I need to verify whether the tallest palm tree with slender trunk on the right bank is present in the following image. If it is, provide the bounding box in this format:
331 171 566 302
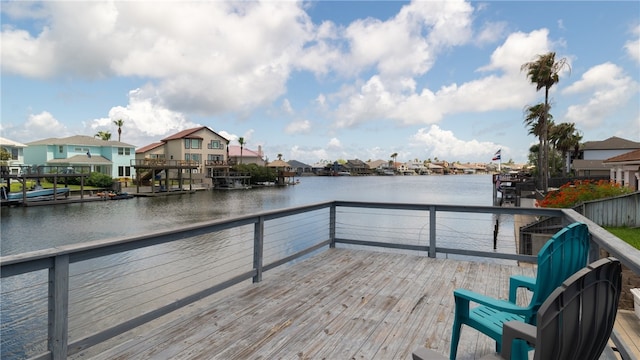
520 52 569 192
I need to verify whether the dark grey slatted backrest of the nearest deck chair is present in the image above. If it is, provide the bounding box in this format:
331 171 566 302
534 258 622 360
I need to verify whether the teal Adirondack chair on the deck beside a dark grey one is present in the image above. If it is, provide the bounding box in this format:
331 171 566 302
449 222 589 360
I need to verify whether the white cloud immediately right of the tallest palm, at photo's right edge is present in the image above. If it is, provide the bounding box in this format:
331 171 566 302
562 63 639 129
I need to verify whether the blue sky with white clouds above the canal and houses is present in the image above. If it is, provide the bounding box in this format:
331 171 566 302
0 0 640 164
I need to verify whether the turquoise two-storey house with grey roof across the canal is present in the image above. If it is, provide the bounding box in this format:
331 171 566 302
23 135 135 179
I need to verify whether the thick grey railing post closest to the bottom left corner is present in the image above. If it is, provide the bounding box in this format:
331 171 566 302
47 255 69 360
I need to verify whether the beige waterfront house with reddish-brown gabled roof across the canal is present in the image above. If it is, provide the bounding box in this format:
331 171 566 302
136 126 231 182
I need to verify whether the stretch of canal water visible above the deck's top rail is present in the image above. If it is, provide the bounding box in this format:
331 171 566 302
0 175 493 256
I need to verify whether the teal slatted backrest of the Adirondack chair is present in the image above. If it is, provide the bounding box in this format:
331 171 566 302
527 222 590 323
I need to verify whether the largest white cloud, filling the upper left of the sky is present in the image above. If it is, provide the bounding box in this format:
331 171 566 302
2 1 311 114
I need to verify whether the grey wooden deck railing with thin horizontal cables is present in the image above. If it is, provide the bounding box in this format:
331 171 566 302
0 201 640 359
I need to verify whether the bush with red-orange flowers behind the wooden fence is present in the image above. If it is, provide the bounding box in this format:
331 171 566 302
537 180 631 208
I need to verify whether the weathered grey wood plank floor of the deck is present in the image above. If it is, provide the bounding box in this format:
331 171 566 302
78 249 534 360
